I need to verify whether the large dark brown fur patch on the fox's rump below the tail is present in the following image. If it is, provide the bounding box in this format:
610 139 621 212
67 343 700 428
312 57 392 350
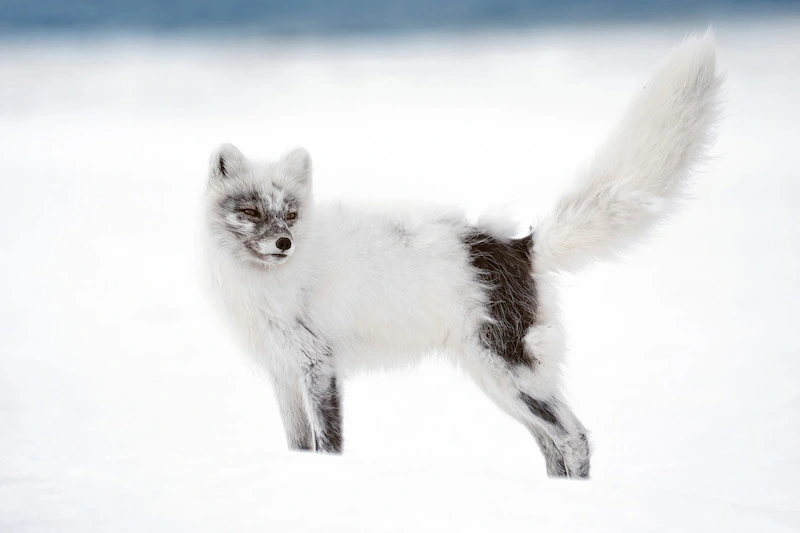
463 230 536 366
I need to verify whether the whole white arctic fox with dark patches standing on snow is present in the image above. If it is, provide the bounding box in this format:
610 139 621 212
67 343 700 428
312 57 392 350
200 34 720 478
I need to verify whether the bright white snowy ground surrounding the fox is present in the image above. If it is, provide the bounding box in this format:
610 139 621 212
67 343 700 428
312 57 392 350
0 20 800 533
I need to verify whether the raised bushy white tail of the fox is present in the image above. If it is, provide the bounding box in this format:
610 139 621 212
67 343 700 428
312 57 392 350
534 31 720 273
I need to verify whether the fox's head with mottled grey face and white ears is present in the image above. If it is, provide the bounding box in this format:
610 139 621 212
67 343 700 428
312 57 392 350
207 144 311 266
